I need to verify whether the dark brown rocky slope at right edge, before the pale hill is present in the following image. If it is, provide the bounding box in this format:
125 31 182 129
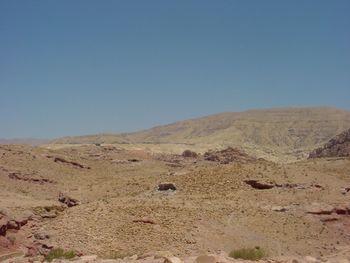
309 129 350 158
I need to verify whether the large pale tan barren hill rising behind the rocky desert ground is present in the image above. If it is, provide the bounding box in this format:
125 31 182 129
52 107 350 160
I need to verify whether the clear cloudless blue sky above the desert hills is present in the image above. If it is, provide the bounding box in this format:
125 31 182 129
0 0 350 138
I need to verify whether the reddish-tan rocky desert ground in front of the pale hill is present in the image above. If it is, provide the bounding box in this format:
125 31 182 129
0 144 350 262
